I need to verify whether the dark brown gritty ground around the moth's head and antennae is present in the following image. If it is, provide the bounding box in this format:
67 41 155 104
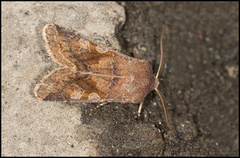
78 2 239 156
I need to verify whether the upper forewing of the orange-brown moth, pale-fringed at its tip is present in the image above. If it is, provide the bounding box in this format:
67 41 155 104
43 24 114 71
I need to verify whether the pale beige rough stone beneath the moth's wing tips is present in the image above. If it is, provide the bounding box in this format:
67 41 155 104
1 2 125 156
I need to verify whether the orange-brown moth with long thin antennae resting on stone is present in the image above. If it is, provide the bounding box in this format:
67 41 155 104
34 24 174 135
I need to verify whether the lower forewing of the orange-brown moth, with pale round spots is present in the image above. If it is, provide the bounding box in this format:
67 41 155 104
34 68 115 102
